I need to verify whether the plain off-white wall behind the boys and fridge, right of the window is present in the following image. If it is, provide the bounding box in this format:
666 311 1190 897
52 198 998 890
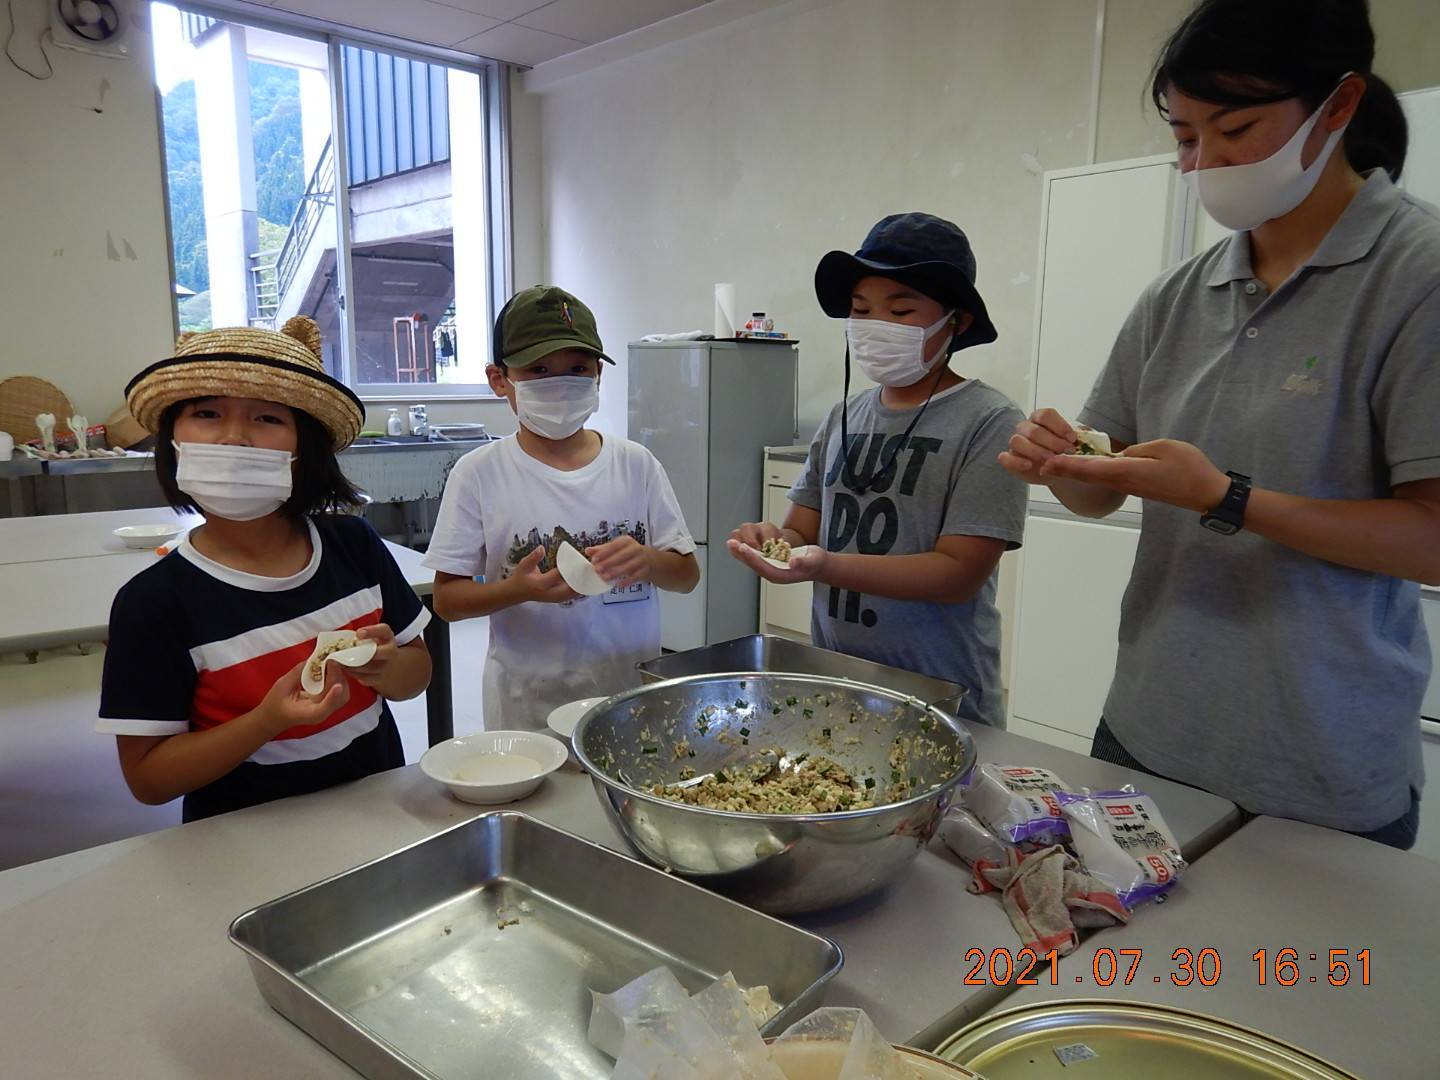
541 0 1094 432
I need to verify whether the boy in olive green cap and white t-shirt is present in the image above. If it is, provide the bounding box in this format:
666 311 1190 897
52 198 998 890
425 285 700 729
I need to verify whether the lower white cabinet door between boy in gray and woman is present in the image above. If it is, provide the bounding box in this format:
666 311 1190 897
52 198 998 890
1009 516 1140 743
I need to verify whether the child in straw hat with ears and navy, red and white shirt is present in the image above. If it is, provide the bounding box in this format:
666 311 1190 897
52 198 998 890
96 317 431 821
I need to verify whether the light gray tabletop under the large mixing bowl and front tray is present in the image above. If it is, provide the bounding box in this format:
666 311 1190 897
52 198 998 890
0 714 1234 1079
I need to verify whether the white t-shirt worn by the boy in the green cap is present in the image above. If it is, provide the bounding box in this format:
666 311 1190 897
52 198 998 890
425 435 696 730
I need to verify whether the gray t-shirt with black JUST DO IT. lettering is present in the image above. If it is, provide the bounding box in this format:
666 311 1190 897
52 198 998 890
789 379 1025 727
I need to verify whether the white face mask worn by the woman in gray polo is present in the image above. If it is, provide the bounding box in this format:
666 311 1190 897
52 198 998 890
1185 75 1349 232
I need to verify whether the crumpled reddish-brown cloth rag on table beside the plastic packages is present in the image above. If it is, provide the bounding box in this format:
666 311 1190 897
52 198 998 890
975 844 1130 956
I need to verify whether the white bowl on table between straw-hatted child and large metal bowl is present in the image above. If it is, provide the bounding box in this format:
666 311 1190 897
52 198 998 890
420 732 566 805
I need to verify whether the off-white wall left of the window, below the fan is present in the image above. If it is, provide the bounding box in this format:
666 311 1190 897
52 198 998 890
0 0 174 423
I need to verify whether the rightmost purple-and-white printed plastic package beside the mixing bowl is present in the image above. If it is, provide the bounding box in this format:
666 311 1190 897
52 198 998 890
1060 791 1187 907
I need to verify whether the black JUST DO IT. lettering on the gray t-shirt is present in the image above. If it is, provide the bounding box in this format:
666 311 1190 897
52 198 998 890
825 432 945 628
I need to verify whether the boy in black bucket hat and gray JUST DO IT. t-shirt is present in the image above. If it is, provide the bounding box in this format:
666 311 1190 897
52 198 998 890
729 213 1025 727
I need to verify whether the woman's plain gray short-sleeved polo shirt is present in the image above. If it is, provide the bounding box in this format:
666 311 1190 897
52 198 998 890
1080 171 1440 831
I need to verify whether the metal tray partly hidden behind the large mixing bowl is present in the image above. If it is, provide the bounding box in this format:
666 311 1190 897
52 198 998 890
635 634 969 716
